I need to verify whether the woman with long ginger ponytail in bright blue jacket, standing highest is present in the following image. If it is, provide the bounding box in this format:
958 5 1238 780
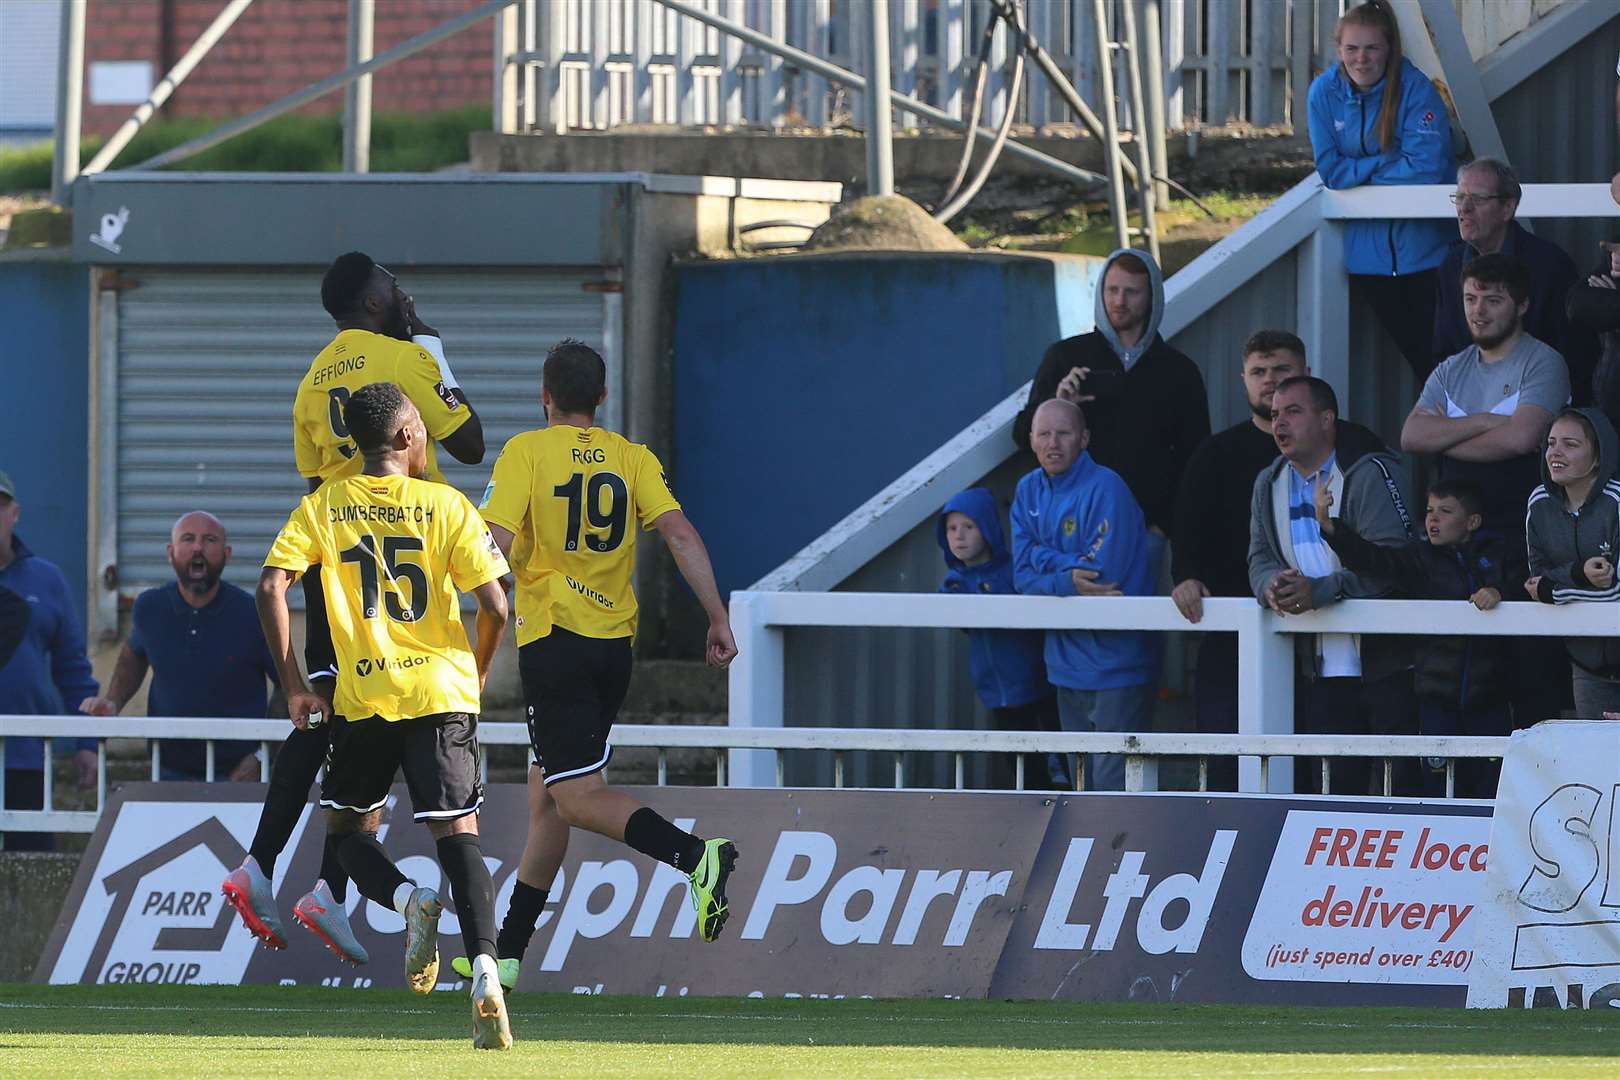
1307 0 1456 382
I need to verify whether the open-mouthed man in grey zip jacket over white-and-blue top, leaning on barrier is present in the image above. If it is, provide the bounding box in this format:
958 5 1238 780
1249 376 1418 795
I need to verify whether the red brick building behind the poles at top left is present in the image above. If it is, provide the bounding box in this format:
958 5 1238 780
84 0 494 134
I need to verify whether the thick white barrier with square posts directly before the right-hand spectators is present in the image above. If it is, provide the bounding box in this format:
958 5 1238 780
731 593 1620 792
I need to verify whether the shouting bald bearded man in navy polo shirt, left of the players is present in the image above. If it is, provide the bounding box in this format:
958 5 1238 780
79 510 275 780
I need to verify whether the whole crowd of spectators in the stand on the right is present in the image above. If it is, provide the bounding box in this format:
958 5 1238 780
940 0 1620 797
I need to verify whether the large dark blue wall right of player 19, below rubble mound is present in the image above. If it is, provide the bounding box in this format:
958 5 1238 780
674 253 1102 594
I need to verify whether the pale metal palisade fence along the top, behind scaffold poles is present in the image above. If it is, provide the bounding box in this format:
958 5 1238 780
496 0 1338 133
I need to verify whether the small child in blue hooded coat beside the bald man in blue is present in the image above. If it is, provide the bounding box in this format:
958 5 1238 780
936 487 1074 790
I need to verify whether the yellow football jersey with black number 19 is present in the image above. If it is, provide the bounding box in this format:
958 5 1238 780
480 424 680 646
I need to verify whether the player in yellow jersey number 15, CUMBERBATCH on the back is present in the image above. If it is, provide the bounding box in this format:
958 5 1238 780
258 382 512 1049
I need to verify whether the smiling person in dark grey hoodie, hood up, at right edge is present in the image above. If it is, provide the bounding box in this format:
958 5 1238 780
1524 408 1620 721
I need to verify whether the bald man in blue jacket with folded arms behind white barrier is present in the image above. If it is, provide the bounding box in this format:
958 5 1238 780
1013 398 1160 790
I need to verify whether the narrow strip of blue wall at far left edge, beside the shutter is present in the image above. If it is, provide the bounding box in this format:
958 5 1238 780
0 259 89 617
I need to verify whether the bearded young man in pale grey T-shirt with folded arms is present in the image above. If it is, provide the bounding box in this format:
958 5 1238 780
1401 254 1570 727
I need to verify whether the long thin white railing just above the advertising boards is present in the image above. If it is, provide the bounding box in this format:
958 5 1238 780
0 714 1508 832
